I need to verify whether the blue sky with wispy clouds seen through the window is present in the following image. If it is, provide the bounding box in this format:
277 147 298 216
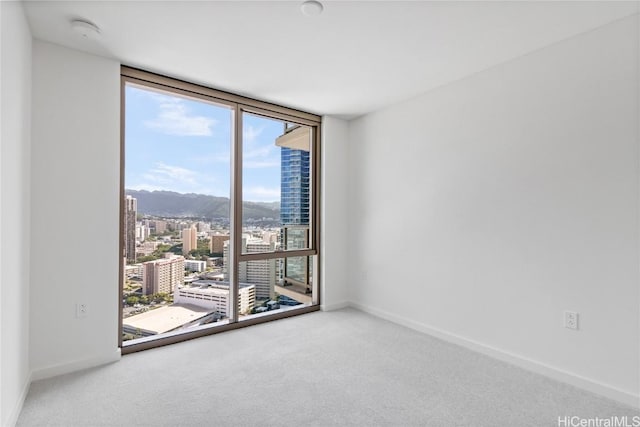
125 84 284 202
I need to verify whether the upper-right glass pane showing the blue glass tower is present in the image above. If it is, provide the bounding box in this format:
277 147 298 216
242 113 312 253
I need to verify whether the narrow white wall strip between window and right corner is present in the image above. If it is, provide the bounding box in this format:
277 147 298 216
320 116 349 310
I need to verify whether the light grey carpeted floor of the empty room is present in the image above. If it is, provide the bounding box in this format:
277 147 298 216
18 309 640 427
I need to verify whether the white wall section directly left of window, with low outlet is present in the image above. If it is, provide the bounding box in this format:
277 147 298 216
31 41 120 379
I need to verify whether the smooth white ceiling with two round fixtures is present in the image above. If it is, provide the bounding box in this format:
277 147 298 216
24 0 640 119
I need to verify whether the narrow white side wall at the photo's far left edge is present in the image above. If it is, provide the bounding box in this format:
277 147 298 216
0 2 31 426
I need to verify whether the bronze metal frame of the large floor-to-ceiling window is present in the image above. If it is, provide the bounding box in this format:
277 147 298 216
117 65 322 354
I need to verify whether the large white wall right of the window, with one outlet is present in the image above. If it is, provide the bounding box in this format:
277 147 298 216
349 17 640 405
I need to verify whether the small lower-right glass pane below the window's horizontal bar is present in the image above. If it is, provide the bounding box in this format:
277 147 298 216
239 256 313 321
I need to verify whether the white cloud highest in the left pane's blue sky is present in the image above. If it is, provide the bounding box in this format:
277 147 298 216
144 94 217 136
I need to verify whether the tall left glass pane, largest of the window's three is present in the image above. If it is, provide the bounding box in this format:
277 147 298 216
122 84 233 341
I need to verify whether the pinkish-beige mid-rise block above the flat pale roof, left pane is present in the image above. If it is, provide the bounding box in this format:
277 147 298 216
142 255 184 295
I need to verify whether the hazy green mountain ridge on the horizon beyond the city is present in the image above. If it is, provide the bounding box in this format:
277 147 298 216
125 190 280 220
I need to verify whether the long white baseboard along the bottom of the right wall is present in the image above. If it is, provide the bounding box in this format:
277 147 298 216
349 302 640 409
